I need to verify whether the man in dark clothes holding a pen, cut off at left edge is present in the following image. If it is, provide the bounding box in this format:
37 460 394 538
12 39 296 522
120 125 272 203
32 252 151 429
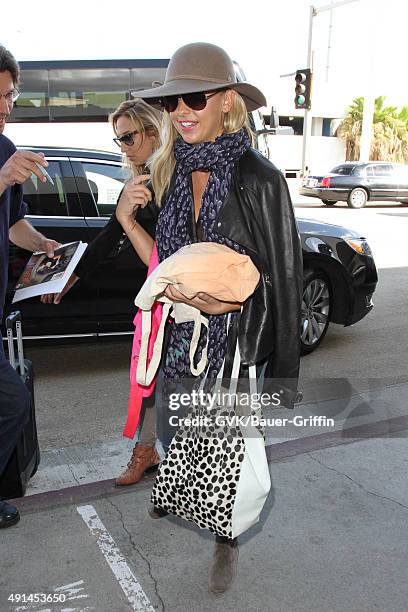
0 45 58 528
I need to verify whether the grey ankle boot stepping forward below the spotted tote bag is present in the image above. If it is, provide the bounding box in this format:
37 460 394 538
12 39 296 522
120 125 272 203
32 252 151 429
208 536 238 593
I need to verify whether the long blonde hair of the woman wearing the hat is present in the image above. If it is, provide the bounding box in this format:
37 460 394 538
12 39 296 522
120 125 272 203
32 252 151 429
150 91 255 206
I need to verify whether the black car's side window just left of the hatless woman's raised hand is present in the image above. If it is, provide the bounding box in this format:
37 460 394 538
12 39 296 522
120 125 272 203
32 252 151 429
82 162 131 217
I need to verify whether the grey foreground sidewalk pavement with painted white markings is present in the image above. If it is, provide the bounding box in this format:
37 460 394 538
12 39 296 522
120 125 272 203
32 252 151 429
0 432 408 612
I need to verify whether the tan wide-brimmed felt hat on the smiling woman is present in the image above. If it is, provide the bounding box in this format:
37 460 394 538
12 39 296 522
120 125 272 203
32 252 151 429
132 43 266 111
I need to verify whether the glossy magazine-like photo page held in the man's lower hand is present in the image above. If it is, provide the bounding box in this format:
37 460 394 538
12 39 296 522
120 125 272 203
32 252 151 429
13 241 88 302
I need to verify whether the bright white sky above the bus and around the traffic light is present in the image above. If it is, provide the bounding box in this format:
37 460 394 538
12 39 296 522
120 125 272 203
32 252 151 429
0 0 408 116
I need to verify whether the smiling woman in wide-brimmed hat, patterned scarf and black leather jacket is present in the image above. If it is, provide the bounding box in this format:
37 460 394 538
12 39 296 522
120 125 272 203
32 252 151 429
122 43 302 593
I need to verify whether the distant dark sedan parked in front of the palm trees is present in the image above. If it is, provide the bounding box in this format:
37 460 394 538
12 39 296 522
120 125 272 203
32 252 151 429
300 162 408 208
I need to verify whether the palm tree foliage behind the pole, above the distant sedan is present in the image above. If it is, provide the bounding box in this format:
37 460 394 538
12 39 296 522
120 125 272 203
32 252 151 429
338 96 408 162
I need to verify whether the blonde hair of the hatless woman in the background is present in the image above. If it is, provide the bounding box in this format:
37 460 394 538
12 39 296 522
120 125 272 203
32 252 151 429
109 98 161 176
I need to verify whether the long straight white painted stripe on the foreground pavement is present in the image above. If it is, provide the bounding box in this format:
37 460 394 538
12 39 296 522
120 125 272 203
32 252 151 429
77 505 154 612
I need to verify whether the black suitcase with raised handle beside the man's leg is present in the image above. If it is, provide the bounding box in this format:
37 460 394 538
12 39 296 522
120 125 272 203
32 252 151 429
0 311 40 499
